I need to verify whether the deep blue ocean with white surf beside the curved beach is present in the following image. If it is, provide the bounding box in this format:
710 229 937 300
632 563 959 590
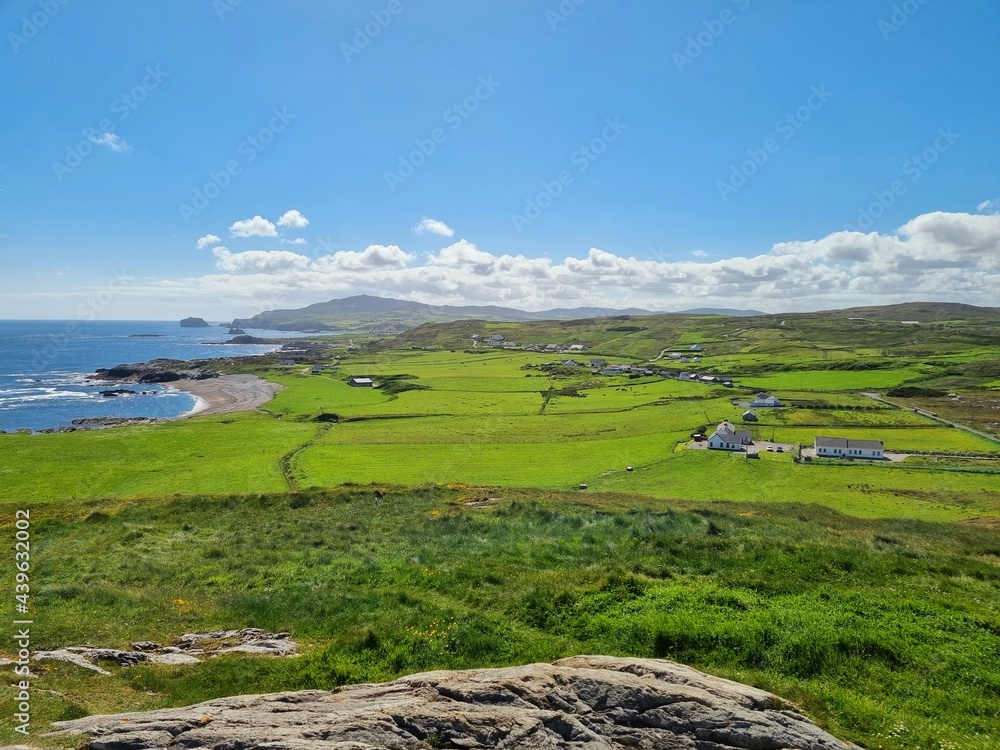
0 320 301 432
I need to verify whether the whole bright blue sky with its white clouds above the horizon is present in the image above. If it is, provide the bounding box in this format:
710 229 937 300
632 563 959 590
0 0 1000 319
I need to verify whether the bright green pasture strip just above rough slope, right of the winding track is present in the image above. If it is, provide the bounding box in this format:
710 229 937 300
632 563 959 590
293 432 1000 521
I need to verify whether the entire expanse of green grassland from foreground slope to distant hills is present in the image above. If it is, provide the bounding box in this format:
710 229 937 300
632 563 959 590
0 314 1000 750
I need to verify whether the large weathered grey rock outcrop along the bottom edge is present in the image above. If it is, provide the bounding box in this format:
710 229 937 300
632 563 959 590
56 656 854 750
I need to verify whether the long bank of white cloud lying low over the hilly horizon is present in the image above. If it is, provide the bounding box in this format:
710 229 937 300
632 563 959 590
56 212 1000 318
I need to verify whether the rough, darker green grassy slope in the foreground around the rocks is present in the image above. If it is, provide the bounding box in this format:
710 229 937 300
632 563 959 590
0 488 1000 750
